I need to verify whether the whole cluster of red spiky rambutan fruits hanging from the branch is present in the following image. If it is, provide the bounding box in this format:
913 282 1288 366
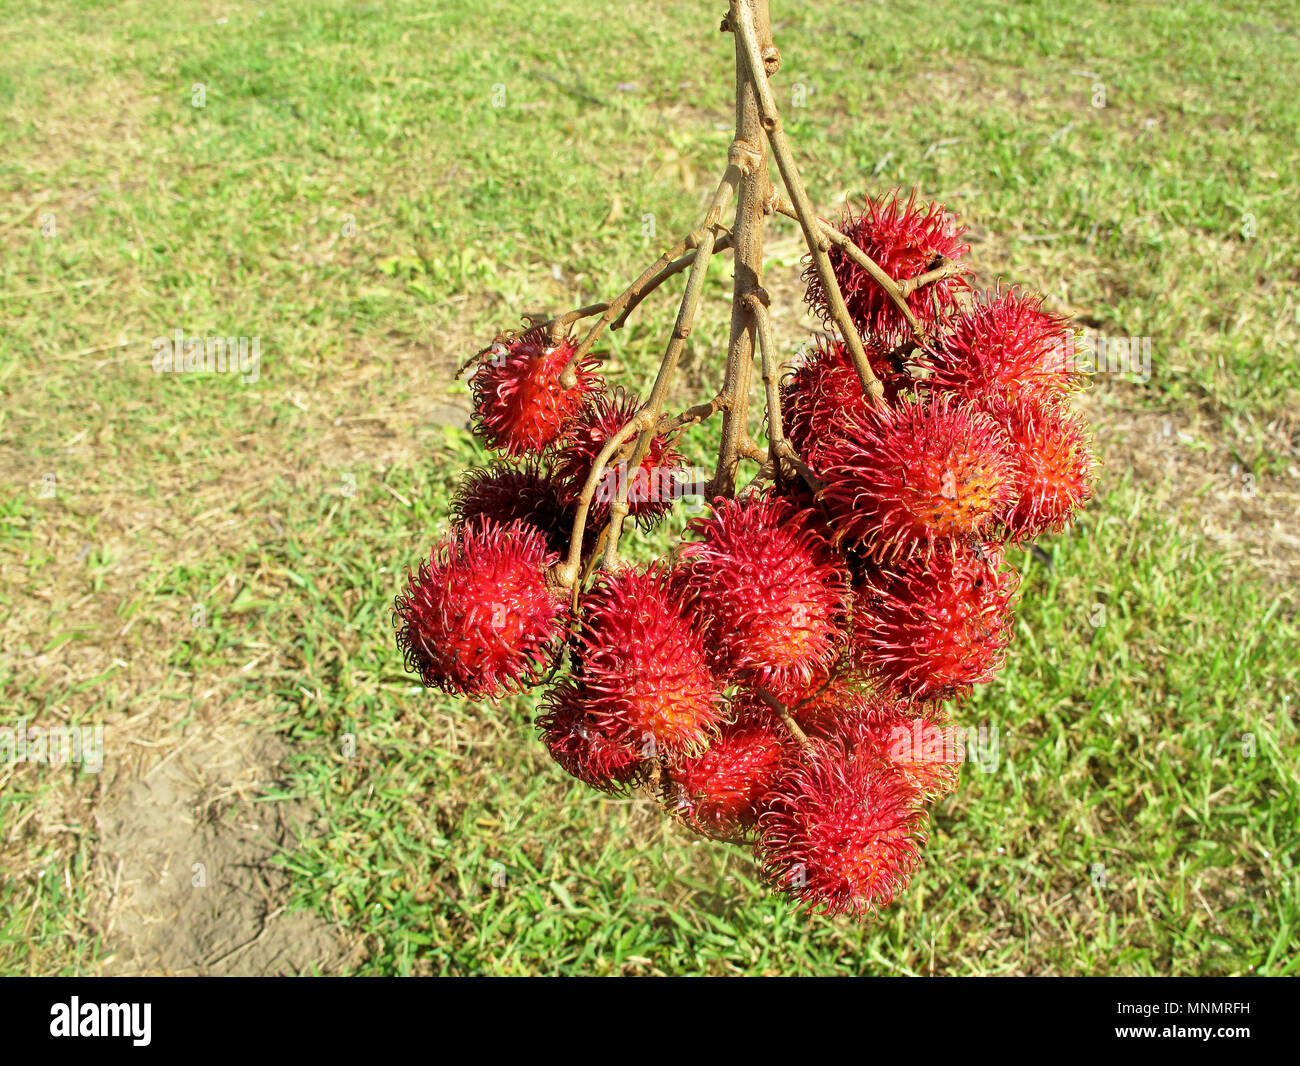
395 187 1096 915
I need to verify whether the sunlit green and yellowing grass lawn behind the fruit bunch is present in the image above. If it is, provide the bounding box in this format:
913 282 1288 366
0 0 1300 974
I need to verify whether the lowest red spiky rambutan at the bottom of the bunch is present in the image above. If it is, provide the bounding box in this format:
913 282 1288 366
758 738 926 917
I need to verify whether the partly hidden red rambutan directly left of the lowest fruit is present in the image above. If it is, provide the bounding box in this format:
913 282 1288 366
667 719 789 837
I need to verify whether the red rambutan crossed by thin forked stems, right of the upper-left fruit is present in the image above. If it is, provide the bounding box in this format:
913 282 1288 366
555 389 686 528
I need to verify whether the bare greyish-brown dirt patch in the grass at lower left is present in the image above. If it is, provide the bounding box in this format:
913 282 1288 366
94 728 350 976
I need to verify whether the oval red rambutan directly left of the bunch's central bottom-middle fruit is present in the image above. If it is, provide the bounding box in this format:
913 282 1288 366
576 567 722 757
